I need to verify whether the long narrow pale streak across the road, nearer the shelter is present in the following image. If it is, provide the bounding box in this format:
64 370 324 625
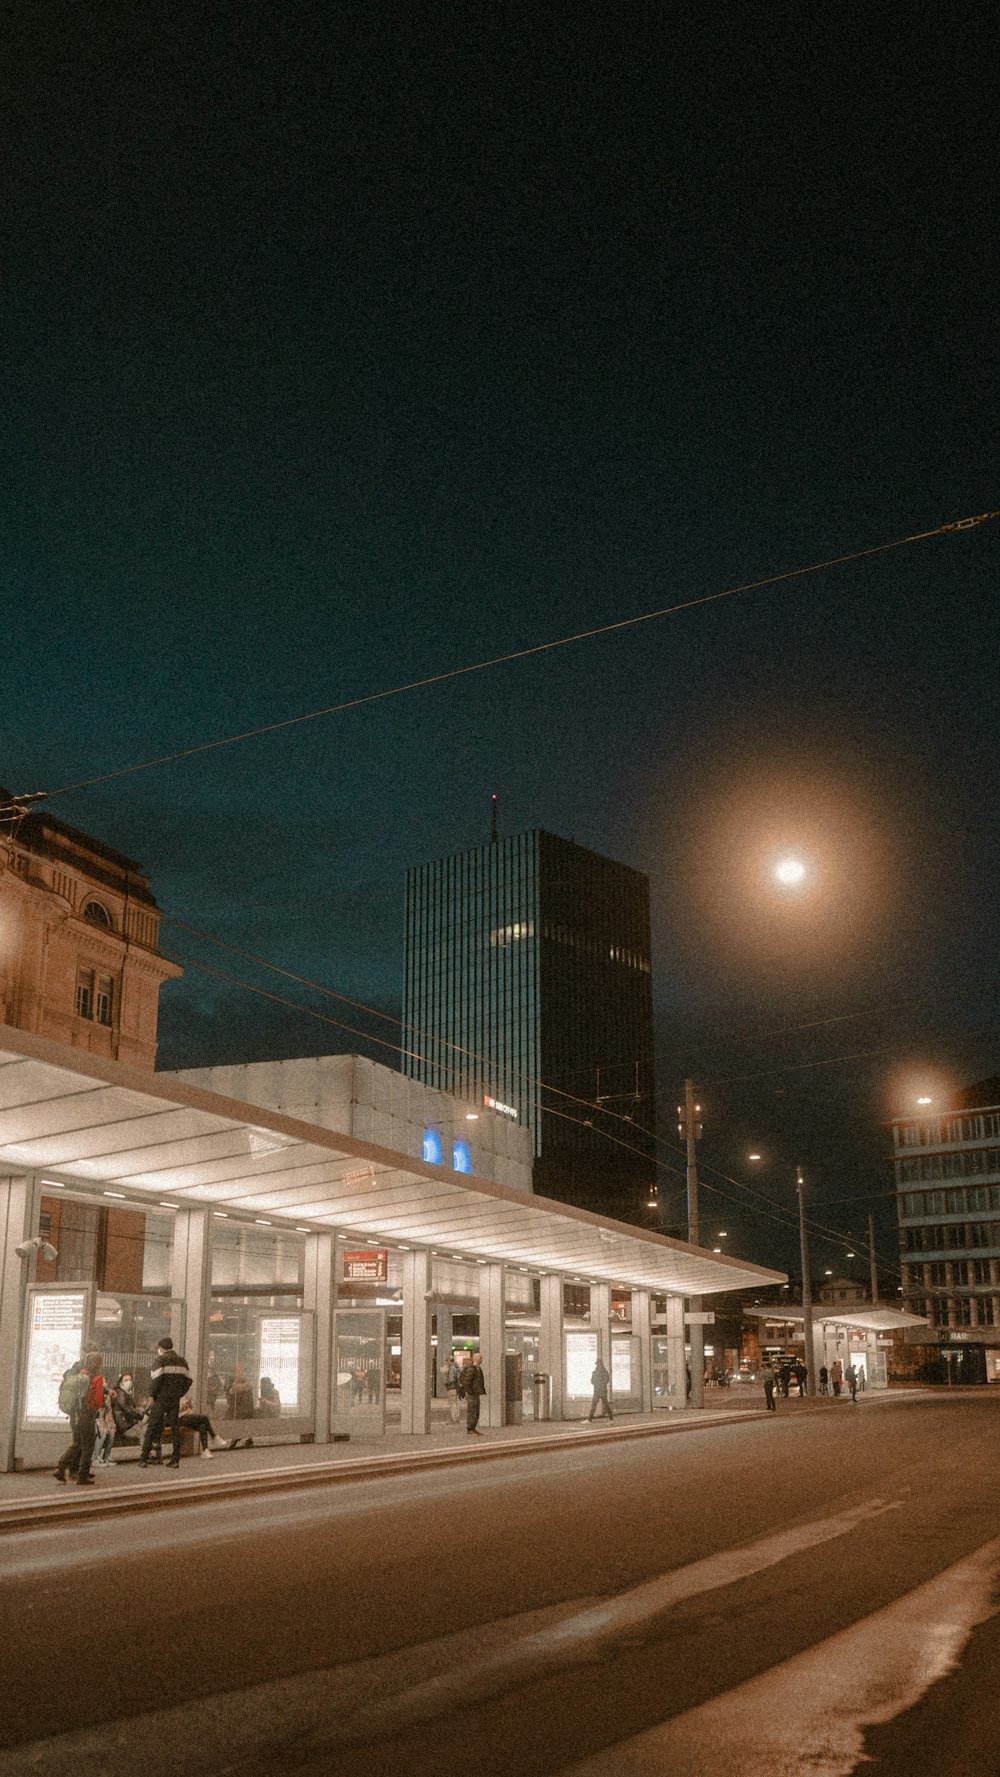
0 1498 906 1777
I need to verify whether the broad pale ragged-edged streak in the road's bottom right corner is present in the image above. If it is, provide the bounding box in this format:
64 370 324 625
560 1537 1000 1777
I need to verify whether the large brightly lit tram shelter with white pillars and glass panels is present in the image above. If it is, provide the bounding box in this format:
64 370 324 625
0 1027 783 1471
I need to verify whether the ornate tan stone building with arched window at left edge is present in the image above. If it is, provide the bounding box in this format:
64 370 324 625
0 789 181 1068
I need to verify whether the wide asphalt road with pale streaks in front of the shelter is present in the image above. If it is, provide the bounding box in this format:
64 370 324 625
0 1390 1000 1777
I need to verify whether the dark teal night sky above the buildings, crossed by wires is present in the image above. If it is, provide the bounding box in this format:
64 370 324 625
0 0 1000 1281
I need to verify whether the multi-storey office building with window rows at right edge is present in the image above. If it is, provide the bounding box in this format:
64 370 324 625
892 1079 1000 1383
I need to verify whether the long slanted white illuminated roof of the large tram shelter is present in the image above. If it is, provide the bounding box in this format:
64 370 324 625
0 1027 785 1295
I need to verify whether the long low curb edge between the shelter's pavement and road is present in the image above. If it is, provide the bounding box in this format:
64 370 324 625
0 1407 766 1535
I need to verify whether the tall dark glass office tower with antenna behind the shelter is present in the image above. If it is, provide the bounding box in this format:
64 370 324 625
403 832 655 1221
